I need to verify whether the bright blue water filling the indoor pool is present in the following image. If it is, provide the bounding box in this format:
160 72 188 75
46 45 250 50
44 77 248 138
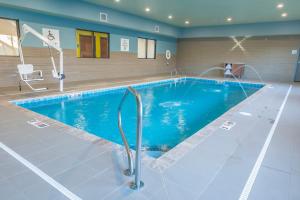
16 78 262 157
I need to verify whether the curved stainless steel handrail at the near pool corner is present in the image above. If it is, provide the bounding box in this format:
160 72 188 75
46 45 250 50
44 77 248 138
118 86 144 190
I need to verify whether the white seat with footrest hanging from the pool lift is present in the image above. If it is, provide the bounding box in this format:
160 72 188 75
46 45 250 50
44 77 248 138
18 64 47 91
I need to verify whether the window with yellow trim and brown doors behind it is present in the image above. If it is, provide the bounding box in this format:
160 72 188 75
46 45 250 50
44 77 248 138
76 30 109 58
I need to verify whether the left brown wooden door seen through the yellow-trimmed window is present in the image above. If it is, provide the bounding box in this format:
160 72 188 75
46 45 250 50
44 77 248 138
79 35 94 58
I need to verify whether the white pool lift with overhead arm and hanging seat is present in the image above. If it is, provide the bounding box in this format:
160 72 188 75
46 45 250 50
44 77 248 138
17 24 65 92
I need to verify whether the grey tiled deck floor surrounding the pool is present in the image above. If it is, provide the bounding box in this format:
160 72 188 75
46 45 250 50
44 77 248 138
0 77 300 200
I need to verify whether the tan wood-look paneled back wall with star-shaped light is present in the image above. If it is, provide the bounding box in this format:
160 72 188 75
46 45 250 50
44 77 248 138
176 36 300 82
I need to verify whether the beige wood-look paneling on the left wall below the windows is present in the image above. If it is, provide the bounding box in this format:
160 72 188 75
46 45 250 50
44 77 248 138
0 48 176 87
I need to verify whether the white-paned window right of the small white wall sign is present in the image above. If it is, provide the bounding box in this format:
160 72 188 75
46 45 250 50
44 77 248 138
138 38 156 59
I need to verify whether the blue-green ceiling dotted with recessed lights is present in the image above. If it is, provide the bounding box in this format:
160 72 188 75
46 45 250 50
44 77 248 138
83 0 300 27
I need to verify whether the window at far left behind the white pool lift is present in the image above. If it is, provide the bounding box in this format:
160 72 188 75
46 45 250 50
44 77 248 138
0 18 19 56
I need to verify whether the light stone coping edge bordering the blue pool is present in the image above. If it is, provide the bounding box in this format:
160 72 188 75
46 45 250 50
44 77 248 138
5 76 271 171
